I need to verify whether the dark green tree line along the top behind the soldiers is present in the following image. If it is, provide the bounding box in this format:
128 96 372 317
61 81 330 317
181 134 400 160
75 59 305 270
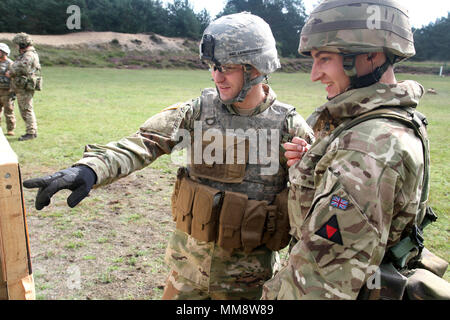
0 0 450 61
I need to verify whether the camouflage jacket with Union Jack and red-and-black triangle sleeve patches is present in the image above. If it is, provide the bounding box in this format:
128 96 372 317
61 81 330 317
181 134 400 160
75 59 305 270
263 81 424 299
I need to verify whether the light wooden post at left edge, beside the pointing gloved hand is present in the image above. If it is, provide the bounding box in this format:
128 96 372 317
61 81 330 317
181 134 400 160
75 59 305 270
0 128 35 300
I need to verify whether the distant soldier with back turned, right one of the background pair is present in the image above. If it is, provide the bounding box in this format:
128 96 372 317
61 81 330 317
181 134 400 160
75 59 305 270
6 33 42 141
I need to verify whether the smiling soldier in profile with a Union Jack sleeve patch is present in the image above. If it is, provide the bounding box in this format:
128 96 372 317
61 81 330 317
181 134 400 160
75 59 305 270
263 0 450 300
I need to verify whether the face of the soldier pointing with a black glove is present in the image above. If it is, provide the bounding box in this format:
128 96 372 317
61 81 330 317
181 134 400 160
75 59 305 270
211 64 244 101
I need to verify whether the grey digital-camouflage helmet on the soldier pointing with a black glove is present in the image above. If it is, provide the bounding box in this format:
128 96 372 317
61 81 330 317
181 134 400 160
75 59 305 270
200 12 280 74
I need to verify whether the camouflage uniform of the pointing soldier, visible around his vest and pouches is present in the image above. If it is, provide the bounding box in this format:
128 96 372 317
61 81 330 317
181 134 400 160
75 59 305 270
77 86 313 299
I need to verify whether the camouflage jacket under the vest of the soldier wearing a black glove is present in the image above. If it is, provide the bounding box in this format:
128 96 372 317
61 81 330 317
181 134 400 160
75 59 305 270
77 86 314 290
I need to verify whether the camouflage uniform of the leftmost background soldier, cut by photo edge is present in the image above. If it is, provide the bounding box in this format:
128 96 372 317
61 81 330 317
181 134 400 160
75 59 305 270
0 58 16 132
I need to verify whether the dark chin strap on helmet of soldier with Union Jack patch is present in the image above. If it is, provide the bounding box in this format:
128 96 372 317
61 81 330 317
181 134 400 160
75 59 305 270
342 53 392 90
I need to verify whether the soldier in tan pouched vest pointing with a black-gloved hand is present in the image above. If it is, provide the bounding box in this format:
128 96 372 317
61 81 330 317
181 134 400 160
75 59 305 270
24 13 313 299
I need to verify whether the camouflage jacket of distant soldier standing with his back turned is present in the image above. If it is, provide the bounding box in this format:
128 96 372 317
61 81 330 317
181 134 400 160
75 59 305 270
10 47 41 90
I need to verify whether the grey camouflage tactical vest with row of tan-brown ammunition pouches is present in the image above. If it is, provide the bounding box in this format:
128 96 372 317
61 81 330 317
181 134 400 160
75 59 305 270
172 89 294 252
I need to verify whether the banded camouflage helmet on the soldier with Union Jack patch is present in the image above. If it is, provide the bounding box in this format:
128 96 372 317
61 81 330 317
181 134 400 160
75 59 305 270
299 0 415 63
